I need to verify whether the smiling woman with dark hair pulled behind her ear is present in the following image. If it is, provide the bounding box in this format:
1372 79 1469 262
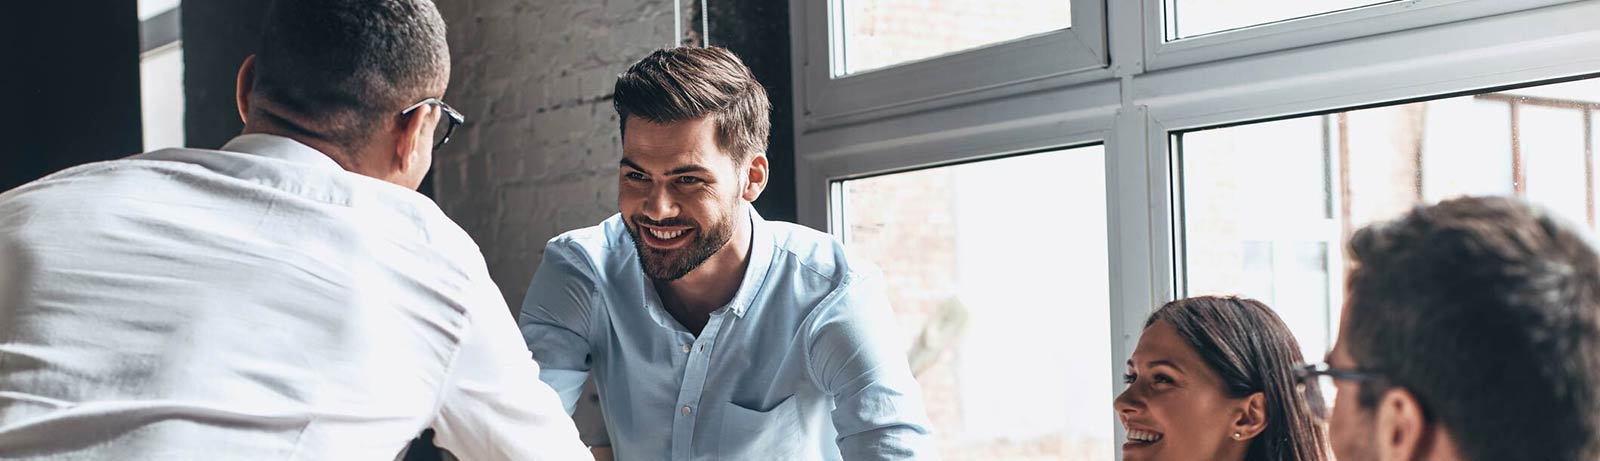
1115 296 1328 461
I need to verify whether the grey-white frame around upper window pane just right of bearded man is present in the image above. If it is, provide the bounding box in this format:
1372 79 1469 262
790 0 1106 128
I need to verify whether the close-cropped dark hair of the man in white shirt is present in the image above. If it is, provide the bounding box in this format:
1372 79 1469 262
253 0 450 147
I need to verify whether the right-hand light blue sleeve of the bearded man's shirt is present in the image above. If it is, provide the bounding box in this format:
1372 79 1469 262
806 270 934 461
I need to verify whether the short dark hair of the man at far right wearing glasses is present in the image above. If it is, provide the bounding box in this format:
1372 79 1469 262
1344 197 1600 461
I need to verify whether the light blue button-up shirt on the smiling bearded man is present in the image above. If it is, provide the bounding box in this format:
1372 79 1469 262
520 206 933 459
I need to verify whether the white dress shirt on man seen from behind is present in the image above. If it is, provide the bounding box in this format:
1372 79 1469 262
0 134 590 459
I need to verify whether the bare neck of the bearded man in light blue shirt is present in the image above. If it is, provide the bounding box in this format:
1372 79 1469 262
656 208 754 317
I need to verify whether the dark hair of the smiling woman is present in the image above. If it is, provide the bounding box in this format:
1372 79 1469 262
1144 296 1328 461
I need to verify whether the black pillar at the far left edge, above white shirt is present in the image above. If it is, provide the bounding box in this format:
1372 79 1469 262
0 0 144 190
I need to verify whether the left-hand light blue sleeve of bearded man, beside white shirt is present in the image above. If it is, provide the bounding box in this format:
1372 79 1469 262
517 240 598 415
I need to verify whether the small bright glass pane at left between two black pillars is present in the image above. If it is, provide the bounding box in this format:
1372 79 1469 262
139 43 184 150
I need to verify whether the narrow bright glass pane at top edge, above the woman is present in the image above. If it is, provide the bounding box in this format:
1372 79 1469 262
1166 0 1395 40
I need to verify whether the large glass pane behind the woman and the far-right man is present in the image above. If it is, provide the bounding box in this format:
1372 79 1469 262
1173 80 1600 359
